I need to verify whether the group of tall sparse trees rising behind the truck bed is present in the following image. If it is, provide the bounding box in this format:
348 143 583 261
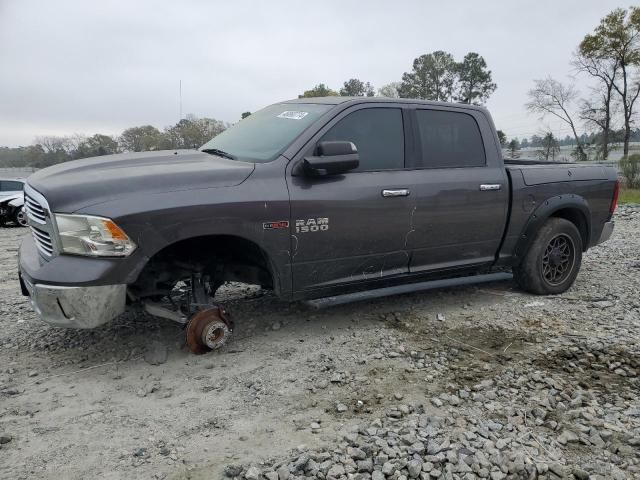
506 7 640 160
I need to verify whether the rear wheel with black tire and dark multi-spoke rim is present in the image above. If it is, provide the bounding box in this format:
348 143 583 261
513 218 582 295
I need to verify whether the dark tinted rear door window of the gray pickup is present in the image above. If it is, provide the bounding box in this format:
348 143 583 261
416 110 486 168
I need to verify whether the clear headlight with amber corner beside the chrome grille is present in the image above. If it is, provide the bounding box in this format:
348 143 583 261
55 213 136 257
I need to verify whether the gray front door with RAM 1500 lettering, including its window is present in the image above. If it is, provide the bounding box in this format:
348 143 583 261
287 103 412 292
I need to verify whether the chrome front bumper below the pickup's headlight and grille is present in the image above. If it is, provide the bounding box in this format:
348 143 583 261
20 276 127 328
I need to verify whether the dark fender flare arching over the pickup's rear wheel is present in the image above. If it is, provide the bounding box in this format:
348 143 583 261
515 193 591 260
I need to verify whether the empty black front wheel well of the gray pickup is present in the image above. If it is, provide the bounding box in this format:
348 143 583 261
130 235 277 298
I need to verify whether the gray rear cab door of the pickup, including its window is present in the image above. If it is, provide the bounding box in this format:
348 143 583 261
407 105 509 272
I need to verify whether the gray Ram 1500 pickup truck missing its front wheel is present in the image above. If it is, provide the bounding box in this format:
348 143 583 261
19 97 618 353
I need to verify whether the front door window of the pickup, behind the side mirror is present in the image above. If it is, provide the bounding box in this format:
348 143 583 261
320 108 404 172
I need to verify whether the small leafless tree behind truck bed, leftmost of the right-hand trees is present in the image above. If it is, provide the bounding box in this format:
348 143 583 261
526 77 586 160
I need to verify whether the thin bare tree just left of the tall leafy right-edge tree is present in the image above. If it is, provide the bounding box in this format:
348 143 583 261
572 53 620 160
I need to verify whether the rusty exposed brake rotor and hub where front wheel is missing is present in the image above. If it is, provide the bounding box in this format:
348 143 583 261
186 307 233 355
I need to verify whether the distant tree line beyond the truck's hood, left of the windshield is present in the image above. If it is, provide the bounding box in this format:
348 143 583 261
0 114 228 168
